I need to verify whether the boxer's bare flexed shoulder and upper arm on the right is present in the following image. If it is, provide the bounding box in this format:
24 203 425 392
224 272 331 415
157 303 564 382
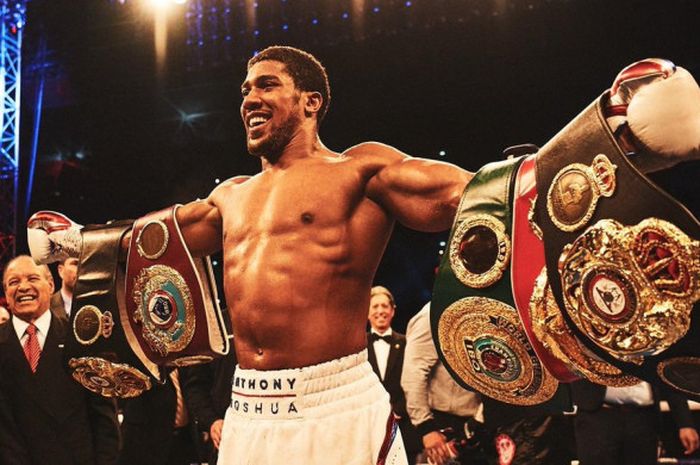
350 142 472 232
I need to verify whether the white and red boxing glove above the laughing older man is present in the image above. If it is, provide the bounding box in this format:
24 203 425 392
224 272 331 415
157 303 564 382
27 210 83 264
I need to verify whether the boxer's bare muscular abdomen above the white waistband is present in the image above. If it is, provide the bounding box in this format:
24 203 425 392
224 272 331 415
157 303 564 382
224 228 381 370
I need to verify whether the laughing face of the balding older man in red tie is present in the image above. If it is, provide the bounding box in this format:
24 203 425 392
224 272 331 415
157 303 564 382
3 257 53 322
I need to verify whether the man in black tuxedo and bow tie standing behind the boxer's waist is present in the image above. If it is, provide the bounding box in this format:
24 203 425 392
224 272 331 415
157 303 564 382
367 286 422 463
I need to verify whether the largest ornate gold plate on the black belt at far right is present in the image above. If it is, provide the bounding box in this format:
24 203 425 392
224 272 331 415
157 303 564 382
559 218 700 364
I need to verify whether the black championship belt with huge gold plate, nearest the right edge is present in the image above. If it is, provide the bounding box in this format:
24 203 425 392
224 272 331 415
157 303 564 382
535 91 700 399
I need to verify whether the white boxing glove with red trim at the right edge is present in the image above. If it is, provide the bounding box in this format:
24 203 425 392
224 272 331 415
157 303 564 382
608 59 700 172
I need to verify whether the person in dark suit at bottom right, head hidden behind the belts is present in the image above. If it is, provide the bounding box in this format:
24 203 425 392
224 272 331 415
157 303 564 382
571 380 699 465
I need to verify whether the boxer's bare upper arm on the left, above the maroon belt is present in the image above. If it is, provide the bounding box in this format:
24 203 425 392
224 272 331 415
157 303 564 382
177 198 222 257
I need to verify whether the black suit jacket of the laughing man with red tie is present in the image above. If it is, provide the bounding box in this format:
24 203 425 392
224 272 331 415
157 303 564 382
0 315 119 465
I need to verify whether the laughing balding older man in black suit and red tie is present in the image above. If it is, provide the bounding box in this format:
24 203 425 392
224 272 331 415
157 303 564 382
0 256 119 465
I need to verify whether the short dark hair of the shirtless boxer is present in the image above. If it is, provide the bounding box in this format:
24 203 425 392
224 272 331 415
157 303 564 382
247 45 331 124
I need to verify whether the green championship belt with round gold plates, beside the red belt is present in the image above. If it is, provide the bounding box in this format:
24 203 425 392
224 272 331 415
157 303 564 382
430 157 558 406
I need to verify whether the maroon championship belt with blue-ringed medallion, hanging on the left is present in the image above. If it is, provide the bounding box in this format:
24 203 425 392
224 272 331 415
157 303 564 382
126 205 229 366
